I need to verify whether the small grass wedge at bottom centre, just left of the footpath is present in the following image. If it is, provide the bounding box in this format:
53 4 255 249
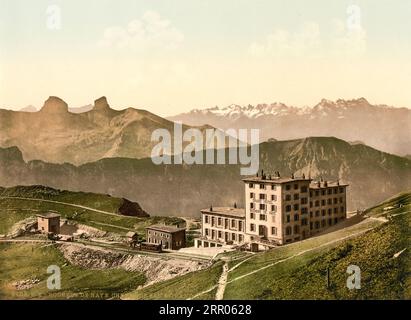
122 262 223 300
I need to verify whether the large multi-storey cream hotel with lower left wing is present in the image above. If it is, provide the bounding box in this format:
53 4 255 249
195 172 348 250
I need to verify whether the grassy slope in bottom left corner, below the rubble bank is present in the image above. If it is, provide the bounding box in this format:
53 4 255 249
0 243 145 299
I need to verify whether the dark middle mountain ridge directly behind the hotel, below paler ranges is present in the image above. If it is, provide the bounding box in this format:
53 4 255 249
0 137 411 216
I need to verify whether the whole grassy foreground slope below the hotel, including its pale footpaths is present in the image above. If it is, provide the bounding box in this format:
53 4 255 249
126 193 411 299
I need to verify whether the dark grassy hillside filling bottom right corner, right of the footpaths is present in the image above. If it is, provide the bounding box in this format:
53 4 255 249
224 194 411 299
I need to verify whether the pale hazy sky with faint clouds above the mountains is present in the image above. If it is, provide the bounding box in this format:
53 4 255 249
0 0 411 115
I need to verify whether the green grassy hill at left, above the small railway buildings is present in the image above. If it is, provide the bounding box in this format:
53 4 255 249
0 186 184 236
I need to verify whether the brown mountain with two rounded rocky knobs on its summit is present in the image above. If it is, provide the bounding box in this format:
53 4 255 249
0 97 222 164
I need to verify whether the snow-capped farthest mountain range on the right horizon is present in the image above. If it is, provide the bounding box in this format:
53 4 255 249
168 98 411 155
